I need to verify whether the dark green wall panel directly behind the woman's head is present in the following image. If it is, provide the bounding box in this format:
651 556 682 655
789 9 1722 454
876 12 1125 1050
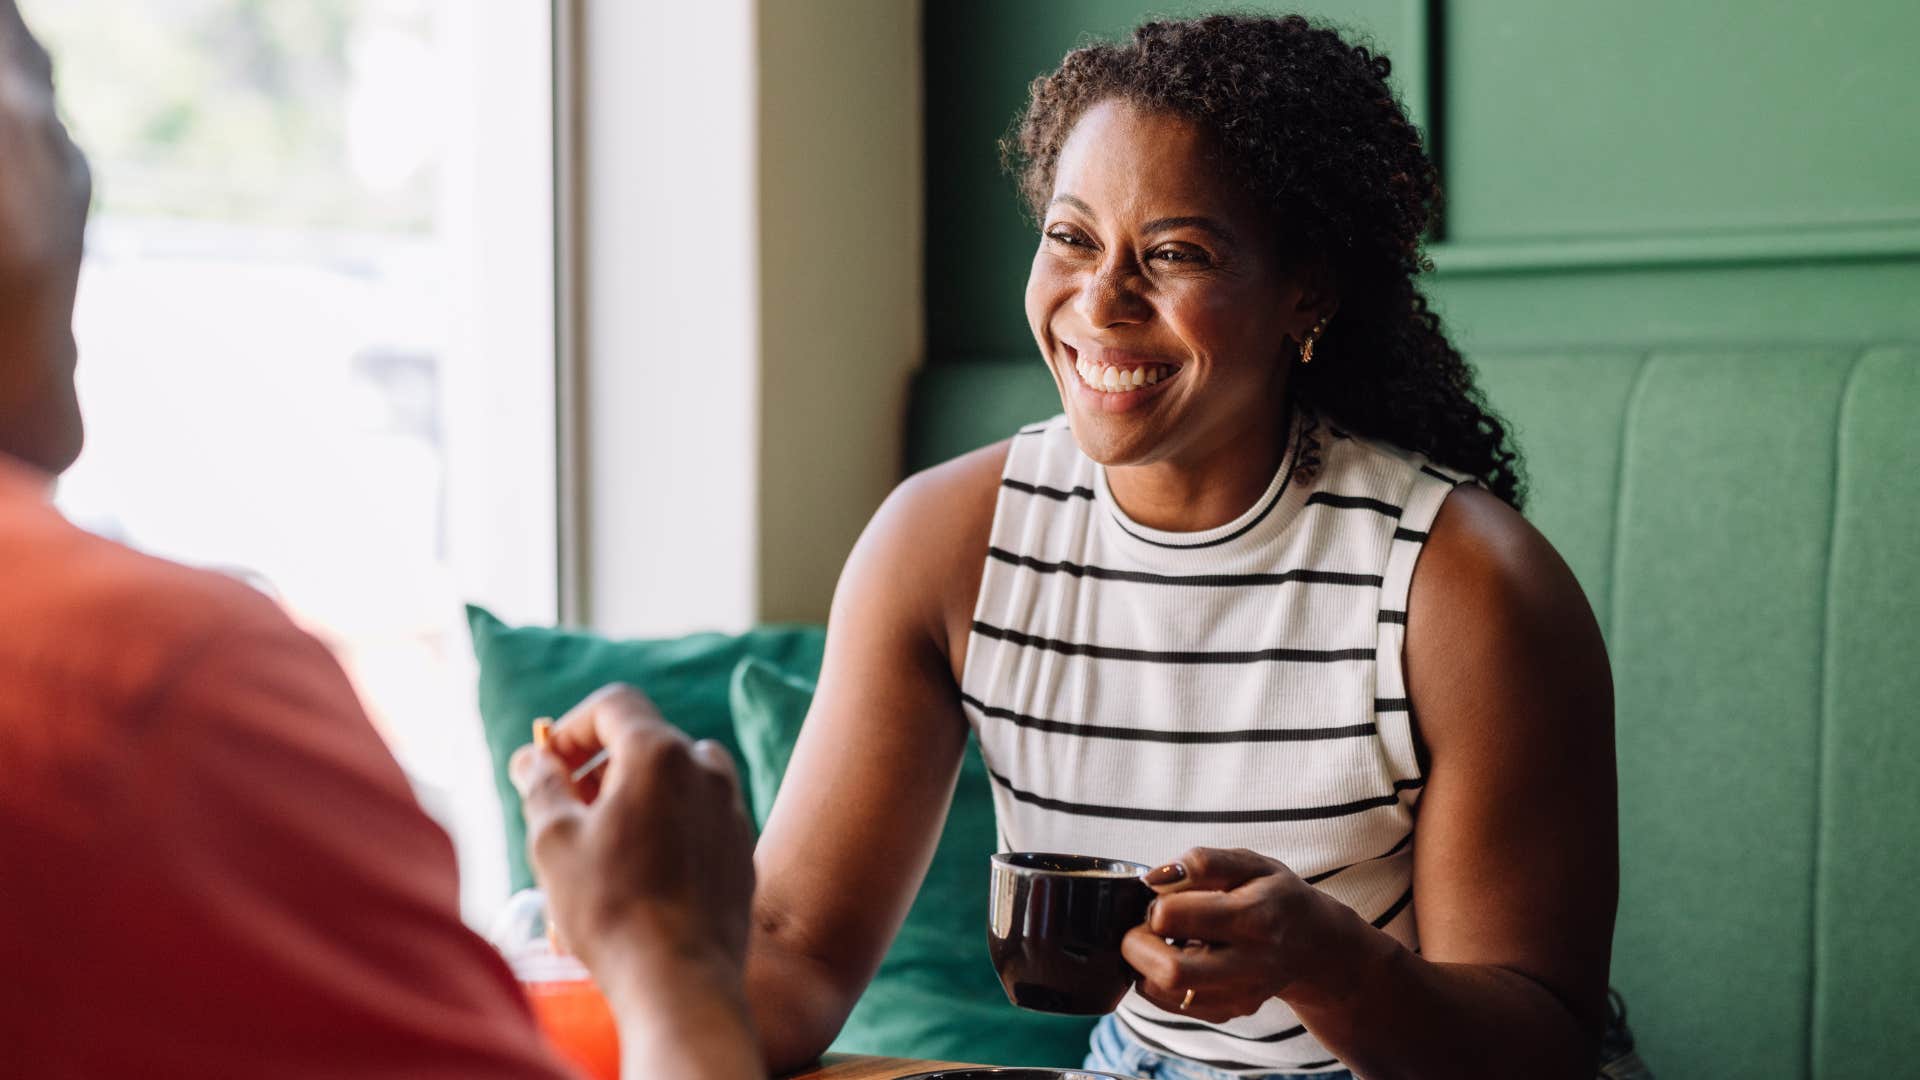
925 0 1427 361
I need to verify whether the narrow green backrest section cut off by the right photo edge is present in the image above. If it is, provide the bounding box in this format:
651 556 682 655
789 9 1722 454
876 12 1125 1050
1812 348 1920 1078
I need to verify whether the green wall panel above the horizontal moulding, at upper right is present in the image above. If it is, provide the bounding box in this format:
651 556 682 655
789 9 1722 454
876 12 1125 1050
1444 0 1920 240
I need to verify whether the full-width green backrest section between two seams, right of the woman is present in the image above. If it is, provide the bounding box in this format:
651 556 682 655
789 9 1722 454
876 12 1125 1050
1605 352 1853 1080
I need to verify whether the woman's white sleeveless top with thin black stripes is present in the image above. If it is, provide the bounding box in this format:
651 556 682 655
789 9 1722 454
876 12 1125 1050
960 407 1467 1072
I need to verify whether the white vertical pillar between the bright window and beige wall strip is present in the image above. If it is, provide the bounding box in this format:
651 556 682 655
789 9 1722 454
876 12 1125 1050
561 0 760 636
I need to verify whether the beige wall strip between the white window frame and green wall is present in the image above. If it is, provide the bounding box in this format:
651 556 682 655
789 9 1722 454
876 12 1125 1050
758 0 924 621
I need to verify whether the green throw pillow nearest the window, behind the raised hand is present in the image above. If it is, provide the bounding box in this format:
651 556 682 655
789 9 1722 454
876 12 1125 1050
467 605 826 890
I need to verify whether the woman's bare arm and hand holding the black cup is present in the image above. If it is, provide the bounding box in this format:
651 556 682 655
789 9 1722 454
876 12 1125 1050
1127 488 1619 1080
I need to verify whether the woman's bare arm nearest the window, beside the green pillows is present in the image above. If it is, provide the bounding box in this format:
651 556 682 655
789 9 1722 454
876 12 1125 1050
747 446 1006 1072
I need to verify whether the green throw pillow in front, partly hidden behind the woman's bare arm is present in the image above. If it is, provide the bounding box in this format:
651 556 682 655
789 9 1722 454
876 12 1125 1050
733 657 1092 1068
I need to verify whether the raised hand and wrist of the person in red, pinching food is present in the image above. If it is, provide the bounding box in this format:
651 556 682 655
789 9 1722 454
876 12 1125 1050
509 686 760 1078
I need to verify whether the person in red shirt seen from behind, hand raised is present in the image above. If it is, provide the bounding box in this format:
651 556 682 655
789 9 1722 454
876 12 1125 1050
0 0 760 1080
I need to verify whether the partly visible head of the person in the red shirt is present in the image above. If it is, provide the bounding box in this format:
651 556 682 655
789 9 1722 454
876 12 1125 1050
0 0 92 473
